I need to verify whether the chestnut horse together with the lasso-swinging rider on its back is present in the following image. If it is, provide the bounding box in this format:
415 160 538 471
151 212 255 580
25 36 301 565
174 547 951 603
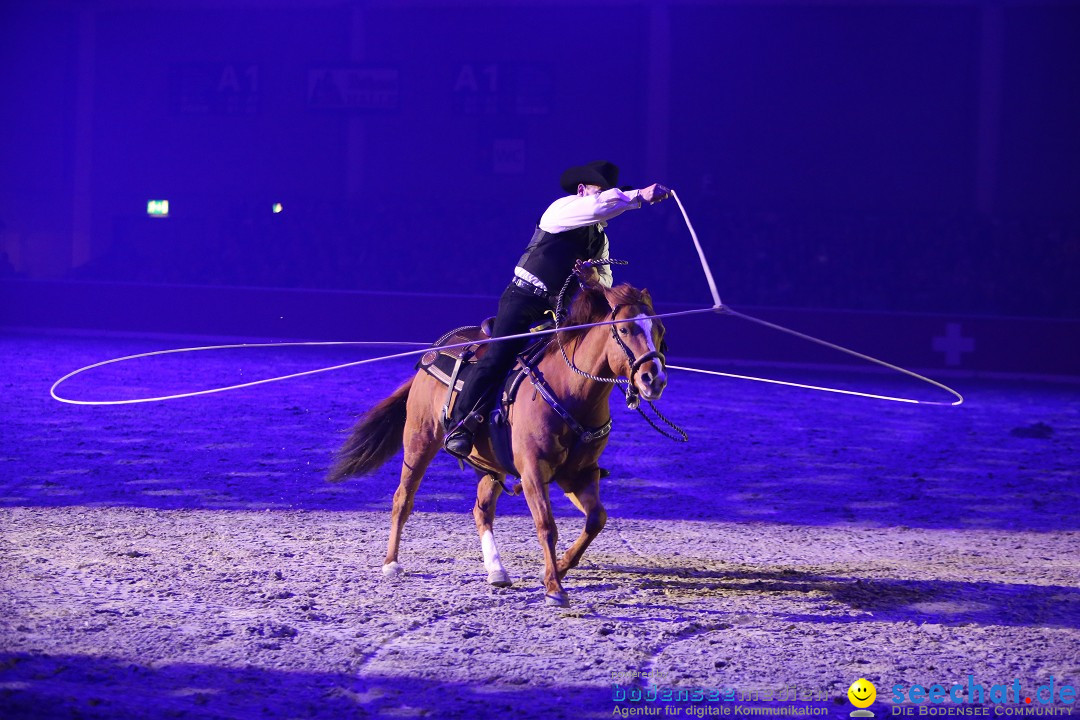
327 162 673 607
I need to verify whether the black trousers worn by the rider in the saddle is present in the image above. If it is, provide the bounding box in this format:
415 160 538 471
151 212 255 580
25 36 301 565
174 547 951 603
450 285 552 424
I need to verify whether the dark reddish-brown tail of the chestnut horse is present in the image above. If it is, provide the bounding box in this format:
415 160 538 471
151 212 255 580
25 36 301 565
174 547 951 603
326 378 415 483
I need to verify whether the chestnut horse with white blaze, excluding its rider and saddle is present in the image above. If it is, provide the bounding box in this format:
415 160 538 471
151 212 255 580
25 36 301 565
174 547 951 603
328 285 667 607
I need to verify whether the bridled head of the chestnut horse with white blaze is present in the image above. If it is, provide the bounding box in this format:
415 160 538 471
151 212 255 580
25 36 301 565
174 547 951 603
569 284 667 400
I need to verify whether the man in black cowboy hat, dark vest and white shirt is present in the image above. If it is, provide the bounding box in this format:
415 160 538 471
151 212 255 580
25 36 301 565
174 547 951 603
444 161 670 459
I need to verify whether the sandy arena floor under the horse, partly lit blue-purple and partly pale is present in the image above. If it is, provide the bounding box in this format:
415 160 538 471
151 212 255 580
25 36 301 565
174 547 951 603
0 335 1080 719
